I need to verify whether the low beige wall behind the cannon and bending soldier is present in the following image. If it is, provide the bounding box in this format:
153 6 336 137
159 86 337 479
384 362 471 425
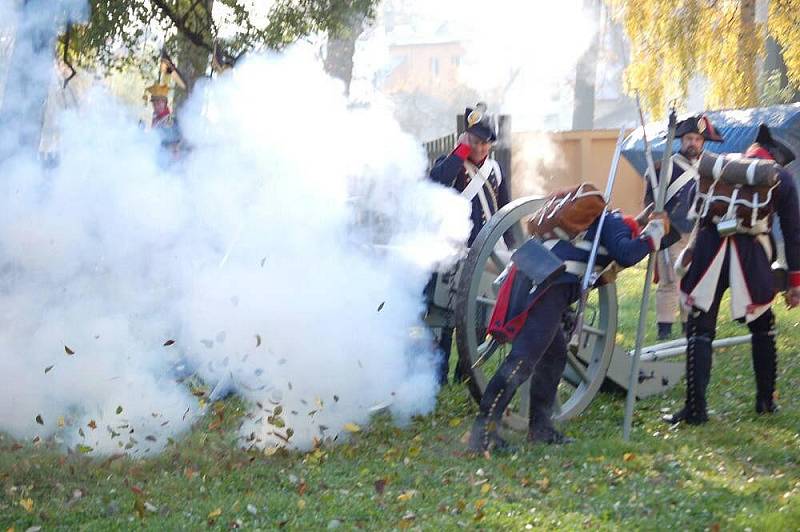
511 129 644 214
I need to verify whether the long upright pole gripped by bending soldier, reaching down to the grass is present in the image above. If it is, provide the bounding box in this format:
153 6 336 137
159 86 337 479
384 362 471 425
622 107 677 440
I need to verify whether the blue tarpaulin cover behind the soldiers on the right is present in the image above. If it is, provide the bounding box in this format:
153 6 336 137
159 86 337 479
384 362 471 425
622 103 800 176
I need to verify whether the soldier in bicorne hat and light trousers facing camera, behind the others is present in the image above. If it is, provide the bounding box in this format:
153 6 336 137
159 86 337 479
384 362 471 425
645 115 723 340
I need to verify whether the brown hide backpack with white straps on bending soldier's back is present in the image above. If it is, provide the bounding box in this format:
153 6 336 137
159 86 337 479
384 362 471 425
528 183 606 240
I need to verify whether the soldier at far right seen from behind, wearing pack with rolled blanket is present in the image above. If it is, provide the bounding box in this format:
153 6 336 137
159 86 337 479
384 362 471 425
664 124 800 425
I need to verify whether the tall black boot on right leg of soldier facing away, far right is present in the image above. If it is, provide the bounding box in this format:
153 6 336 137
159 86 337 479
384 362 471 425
750 310 778 414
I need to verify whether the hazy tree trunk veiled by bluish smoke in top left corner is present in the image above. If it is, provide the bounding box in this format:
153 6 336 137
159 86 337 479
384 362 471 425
0 0 61 161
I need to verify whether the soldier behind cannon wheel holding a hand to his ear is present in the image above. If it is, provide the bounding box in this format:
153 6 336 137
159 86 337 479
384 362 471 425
430 103 511 384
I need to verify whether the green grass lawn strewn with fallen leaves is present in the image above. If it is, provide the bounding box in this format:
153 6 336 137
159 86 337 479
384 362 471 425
0 268 800 531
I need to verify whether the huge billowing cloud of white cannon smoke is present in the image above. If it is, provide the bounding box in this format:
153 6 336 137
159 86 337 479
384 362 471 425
0 2 469 454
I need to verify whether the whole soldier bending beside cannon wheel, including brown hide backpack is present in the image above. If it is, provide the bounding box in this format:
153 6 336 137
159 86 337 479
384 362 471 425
469 184 669 452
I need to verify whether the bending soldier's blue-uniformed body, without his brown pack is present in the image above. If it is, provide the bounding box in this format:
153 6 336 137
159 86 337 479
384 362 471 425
469 202 669 453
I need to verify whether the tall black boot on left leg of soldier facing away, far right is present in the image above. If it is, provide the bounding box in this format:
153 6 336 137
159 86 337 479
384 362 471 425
662 328 713 425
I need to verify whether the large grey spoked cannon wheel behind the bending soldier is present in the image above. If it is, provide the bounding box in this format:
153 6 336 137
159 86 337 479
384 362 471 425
455 197 617 430
